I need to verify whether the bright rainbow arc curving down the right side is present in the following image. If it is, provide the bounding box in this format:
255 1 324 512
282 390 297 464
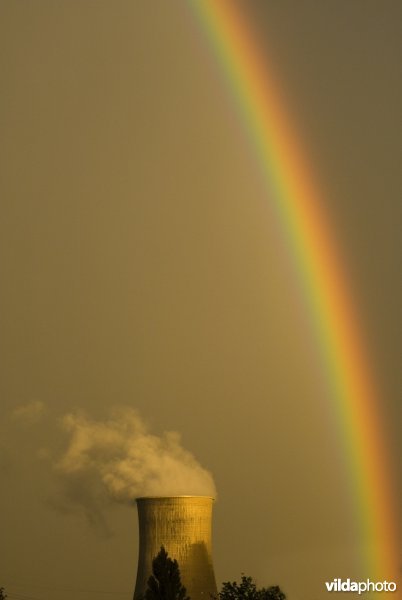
189 0 398 581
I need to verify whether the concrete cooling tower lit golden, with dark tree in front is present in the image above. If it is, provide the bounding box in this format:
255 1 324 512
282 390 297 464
134 496 217 600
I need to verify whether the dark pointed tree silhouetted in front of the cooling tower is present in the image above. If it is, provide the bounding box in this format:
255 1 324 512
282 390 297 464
144 546 190 600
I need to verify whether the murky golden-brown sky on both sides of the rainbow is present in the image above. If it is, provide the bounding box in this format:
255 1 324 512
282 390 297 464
0 0 402 600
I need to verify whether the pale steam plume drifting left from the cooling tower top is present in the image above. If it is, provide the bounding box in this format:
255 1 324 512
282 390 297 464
56 407 216 503
